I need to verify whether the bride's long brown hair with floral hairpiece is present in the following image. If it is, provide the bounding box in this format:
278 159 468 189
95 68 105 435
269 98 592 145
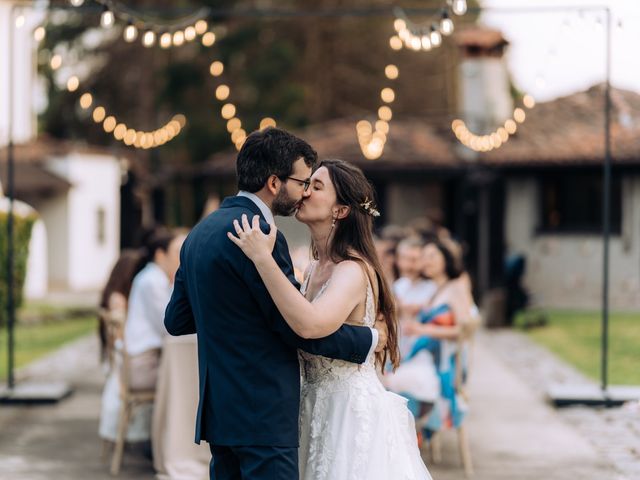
312 159 400 369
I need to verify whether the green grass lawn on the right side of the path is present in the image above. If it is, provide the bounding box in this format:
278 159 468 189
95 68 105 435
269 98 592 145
516 310 640 385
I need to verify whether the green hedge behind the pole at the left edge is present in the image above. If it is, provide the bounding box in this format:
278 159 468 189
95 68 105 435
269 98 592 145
0 212 36 326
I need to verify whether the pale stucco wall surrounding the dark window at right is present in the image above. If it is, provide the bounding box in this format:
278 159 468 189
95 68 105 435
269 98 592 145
505 176 640 310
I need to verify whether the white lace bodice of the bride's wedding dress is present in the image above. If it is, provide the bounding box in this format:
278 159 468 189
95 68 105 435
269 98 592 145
300 264 376 385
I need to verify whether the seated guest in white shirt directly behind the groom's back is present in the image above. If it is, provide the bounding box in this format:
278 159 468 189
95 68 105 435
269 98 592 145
125 229 186 390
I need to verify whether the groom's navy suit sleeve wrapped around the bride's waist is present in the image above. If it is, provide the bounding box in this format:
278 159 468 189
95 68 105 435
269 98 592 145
244 223 372 363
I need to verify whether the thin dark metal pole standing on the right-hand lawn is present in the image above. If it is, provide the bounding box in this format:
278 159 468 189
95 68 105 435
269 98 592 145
600 7 611 397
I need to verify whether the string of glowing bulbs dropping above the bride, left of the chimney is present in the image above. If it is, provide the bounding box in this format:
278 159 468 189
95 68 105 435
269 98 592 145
356 0 467 160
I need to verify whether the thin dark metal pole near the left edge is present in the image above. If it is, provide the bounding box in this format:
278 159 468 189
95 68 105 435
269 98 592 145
7 5 16 389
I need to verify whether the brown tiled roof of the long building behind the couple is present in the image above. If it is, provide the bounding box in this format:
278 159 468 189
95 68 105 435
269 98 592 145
184 85 640 176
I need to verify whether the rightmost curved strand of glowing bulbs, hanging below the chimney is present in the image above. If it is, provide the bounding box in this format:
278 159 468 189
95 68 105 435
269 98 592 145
451 94 535 152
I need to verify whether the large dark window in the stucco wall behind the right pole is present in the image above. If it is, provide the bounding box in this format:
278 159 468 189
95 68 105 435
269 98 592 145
539 172 622 233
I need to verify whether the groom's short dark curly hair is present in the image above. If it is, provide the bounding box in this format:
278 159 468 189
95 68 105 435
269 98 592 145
236 127 318 193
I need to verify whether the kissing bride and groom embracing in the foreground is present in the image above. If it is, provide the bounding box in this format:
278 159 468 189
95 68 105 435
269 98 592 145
165 128 431 480
